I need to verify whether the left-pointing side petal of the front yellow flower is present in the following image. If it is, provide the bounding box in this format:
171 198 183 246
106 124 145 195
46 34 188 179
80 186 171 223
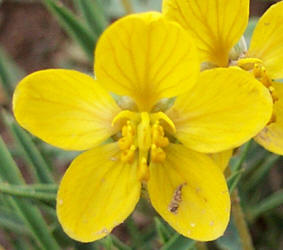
13 69 119 150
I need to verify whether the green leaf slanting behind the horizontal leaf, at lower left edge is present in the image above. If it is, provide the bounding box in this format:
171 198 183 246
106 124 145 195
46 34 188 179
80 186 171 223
0 137 60 250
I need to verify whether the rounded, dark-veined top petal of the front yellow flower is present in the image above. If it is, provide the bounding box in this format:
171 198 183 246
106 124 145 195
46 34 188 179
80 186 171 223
95 12 199 111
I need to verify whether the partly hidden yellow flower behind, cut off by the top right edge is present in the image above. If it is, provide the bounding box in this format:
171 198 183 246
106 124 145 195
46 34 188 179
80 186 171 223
163 0 283 155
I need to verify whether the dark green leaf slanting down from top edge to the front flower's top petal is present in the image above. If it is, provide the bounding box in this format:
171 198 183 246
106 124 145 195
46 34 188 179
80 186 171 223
43 0 97 60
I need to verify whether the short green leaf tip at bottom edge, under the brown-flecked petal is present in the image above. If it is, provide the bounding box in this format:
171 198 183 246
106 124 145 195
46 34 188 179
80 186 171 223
161 233 195 250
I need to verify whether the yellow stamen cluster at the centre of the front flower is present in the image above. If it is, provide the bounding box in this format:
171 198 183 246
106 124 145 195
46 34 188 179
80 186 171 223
112 110 176 181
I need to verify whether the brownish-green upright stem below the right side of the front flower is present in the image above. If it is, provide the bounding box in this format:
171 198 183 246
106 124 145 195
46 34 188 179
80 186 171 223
231 190 254 250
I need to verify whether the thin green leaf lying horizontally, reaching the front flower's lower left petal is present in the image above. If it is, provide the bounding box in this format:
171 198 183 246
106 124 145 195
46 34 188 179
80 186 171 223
0 183 56 201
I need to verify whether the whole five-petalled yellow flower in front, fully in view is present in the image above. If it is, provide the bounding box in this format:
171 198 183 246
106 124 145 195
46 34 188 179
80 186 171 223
13 12 272 242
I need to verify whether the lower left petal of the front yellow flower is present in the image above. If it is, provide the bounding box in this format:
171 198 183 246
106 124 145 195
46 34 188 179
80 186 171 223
57 143 141 242
